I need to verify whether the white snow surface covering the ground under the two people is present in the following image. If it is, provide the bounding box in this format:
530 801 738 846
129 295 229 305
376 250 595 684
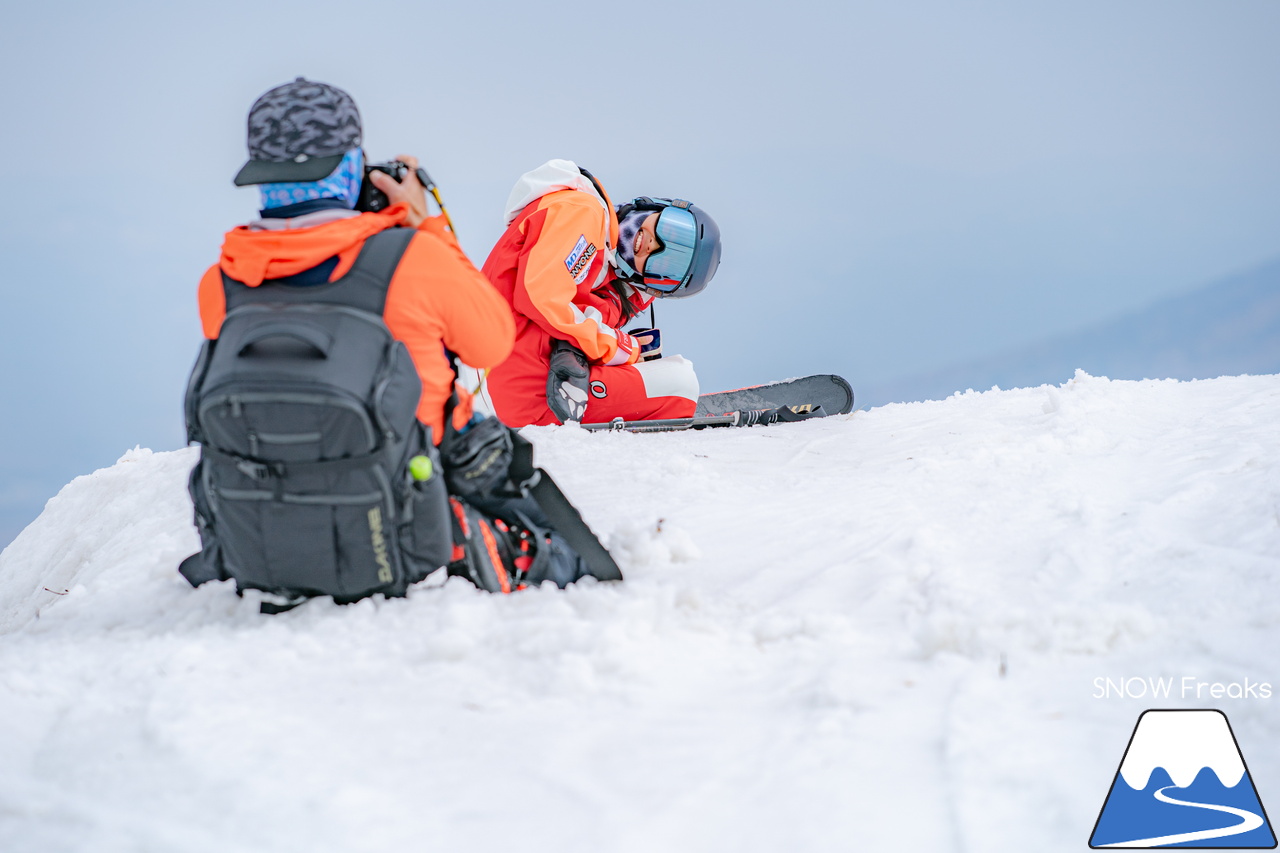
0 374 1280 853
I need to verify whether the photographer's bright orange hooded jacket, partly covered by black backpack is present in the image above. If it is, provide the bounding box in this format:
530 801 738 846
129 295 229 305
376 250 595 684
200 205 515 443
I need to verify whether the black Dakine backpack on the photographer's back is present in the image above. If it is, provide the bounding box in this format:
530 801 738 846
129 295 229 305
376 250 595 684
179 228 453 604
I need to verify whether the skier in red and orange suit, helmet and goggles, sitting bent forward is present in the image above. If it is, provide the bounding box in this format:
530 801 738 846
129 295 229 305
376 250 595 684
483 160 721 427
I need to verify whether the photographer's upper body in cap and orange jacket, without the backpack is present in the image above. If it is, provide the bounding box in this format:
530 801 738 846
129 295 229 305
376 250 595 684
200 77 515 444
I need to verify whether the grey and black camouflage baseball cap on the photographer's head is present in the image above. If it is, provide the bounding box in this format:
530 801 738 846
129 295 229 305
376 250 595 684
236 77 361 187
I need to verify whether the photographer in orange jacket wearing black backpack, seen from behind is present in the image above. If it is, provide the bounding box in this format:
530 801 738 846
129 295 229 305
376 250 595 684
180 77 604 601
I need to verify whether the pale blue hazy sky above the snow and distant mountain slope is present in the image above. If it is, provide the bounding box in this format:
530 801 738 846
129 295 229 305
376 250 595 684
0 0 1280 544
